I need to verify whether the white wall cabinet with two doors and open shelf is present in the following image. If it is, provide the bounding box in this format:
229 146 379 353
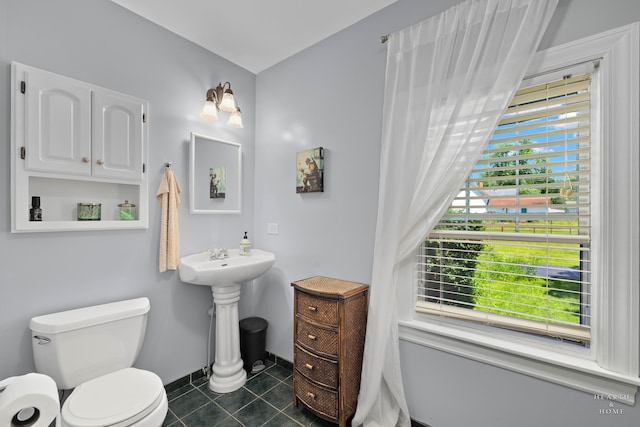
11 62 148 232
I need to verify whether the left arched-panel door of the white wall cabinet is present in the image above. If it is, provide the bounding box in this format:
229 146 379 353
23 68 91 175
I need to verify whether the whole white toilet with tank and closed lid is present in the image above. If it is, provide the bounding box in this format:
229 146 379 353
29 298 168 427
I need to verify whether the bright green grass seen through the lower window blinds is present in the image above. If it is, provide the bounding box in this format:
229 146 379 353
473 221 580 324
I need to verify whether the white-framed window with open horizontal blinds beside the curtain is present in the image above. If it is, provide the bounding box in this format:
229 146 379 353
397 23 640 404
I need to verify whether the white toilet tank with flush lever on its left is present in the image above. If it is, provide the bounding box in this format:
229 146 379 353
29 298 150 389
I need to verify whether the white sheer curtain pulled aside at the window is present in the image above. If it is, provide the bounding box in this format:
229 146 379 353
352 0 557 427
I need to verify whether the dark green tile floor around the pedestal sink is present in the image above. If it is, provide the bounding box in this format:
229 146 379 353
163 360 335 427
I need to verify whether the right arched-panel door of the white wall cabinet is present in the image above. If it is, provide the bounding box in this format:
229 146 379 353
92 90 144 180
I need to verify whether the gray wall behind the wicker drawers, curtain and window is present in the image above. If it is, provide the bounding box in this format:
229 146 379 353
255 0 640 427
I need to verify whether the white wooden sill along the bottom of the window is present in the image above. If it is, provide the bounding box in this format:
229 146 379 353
399 320 640 405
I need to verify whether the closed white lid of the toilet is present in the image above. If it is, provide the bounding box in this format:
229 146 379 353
62 368 164 427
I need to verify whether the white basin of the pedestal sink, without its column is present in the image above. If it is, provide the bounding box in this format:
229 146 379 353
179 249 276 286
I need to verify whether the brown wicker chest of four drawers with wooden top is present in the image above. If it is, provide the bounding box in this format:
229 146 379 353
291 276 369 427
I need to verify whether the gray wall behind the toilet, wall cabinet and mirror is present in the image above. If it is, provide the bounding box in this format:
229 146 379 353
0 0 255 383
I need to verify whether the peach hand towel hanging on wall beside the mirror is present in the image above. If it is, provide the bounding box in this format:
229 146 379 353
156 167 180 273
